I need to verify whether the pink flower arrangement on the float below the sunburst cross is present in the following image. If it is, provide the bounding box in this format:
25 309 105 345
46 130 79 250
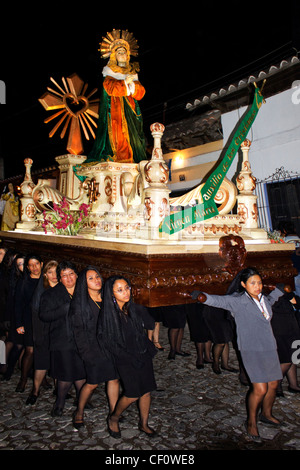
42 197 90 236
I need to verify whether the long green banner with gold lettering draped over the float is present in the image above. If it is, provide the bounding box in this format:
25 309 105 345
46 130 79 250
159 85 264 235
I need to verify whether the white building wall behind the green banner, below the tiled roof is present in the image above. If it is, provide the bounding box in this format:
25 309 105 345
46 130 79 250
164 87 300 195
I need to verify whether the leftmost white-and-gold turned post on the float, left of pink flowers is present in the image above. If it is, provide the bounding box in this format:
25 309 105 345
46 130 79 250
16 158 37 231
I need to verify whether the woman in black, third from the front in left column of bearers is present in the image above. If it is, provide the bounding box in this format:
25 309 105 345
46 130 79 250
40 261 85 416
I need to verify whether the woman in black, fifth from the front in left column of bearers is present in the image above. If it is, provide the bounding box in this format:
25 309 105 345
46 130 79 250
15 254 43 393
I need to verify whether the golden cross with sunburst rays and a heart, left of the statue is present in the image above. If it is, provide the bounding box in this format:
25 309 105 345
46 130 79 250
39 74 99 155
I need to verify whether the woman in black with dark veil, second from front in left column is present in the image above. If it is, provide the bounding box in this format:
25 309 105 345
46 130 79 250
69 266 120 429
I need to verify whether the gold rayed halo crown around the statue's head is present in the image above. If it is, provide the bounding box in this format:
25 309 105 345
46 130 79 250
98 29 139 59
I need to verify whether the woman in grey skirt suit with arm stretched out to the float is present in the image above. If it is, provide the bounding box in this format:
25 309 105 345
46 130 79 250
191 268 283 442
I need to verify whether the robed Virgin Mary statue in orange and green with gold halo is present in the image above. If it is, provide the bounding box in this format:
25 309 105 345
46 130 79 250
85 30 147 163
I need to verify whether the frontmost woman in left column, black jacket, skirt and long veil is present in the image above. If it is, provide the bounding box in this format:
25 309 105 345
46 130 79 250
98 276 157 438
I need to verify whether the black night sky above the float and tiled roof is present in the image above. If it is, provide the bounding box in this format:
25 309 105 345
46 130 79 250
0 1 300 177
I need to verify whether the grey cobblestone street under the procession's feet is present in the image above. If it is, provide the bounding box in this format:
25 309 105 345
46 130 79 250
0 327 300 453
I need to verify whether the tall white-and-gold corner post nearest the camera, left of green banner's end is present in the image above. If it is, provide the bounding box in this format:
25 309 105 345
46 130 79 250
144 123 170 238
